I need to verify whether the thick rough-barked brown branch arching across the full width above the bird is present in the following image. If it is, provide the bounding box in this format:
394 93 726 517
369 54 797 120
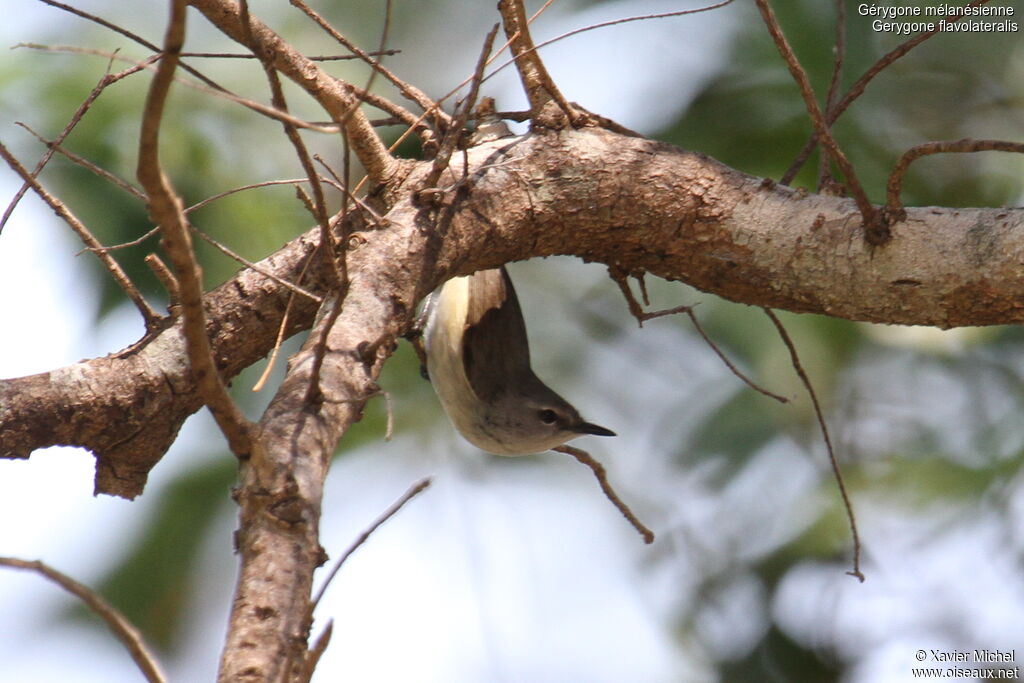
0 128 1024 497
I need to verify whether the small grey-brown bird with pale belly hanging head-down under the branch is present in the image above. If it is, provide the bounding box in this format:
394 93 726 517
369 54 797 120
424 266 615 456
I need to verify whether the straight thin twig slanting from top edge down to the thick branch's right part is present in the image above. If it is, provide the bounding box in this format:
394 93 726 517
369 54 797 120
755 0 892 246
